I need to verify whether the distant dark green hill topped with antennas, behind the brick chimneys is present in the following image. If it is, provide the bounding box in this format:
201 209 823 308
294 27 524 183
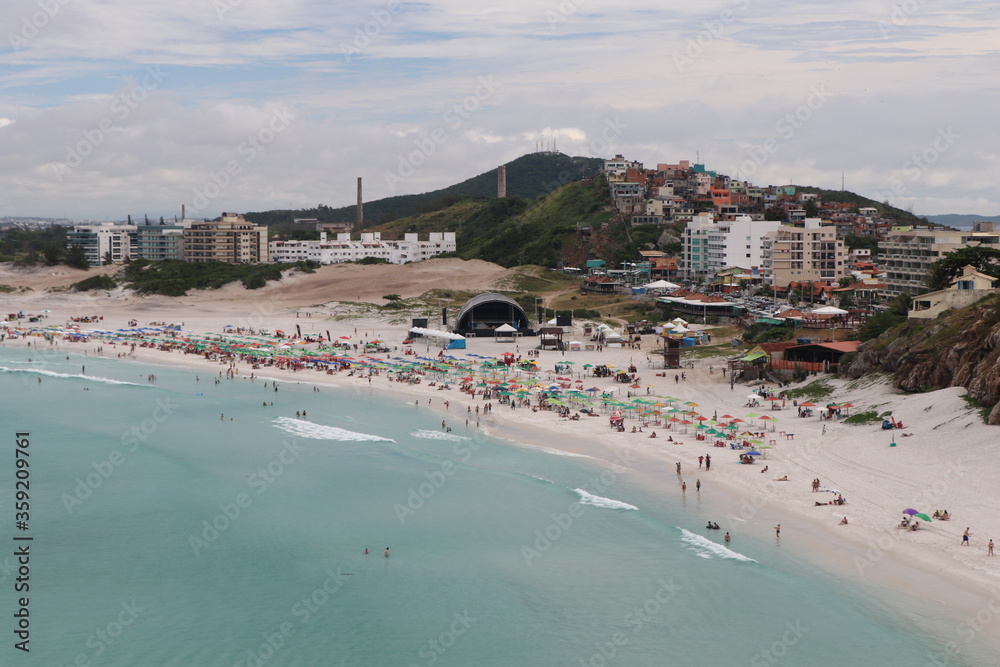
245 153 604 227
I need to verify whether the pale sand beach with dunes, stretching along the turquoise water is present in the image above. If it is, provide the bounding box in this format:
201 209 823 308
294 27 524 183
0 260 1000 650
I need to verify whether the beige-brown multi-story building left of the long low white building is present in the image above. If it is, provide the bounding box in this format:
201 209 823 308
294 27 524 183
183 213 268 264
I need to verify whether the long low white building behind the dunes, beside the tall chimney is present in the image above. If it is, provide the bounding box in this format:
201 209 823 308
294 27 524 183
269 232 457 264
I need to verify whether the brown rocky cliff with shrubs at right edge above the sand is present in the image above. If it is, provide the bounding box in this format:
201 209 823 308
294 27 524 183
841 296 1000 425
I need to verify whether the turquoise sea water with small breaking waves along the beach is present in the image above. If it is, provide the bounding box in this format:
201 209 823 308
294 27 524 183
0 349 978 667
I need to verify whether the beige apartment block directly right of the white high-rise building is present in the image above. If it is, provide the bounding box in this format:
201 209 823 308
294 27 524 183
761 218 845 287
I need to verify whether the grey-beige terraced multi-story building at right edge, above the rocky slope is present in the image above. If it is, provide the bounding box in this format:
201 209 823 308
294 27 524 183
879 222 1000 296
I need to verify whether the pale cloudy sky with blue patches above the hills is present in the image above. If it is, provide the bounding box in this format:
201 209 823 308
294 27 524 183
0 0 1000 219
